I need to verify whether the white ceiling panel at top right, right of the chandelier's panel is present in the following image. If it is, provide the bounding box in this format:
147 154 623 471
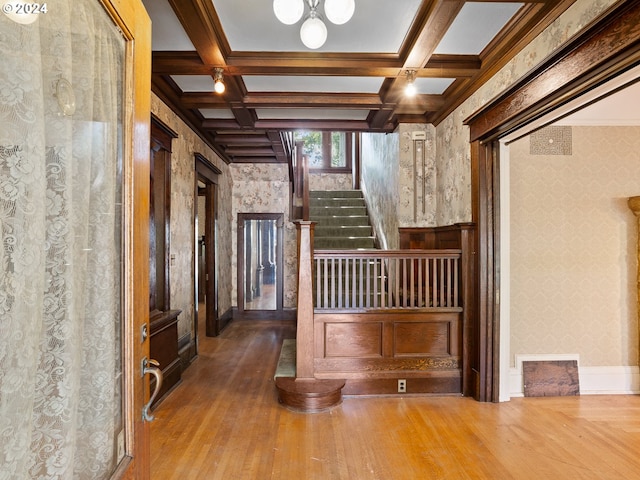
435 2 523 55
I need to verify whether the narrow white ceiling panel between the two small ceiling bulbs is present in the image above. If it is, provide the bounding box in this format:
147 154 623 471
242 75 384 93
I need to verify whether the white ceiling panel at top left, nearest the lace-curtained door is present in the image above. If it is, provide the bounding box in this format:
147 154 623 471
142 0 195 51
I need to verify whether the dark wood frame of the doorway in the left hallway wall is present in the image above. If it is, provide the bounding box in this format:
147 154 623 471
193 153 225 337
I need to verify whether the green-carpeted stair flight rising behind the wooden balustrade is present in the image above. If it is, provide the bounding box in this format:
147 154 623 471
309 190 375 250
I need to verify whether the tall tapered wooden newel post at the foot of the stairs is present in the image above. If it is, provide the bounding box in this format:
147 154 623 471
295 220 316 379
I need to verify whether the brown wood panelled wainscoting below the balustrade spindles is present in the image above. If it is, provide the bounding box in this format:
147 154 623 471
314 309 462 395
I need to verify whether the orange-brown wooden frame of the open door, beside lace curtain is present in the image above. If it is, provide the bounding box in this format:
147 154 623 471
106 0 151 480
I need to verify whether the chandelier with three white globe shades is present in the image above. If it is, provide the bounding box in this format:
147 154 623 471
273 0 356 50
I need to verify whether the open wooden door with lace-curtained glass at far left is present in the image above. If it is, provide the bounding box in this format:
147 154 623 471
0 0 151 479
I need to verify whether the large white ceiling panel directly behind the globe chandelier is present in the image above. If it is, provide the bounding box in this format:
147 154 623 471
212 0 421 53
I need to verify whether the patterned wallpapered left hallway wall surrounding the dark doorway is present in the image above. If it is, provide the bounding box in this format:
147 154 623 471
151 94 235 338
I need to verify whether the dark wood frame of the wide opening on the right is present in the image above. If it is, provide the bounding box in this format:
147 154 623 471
465 2 640 402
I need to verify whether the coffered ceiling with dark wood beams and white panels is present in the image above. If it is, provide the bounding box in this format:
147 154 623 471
143 0 575 162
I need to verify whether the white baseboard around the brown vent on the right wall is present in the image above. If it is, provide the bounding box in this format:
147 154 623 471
509 354 640 398
